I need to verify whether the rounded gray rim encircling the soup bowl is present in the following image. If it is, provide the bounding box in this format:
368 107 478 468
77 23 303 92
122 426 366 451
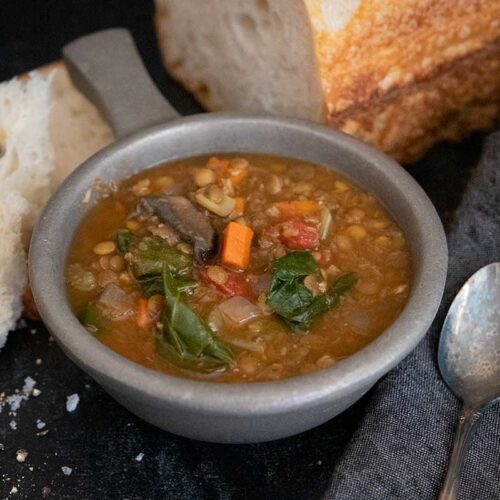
29 113 447 415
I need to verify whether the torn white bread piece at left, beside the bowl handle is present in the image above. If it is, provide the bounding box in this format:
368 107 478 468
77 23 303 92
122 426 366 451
0 63 112 348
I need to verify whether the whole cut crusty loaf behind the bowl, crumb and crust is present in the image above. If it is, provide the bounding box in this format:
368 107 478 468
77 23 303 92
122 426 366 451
156 0 500 162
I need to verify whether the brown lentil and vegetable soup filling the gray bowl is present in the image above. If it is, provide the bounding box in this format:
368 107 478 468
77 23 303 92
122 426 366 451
66 155 410 382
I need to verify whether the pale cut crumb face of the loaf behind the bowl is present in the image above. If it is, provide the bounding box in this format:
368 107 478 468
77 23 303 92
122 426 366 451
156 0 324 121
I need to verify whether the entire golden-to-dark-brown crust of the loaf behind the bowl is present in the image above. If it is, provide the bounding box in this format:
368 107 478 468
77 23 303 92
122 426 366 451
305 0 500 163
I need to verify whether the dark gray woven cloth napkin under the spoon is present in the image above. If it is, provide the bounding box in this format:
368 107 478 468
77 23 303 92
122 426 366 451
327 132 500 500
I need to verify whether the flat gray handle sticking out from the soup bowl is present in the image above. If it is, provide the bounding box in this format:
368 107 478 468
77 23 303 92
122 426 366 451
63 29 179 138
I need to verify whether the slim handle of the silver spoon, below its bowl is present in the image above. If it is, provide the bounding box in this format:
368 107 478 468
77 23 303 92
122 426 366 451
439 406 481 500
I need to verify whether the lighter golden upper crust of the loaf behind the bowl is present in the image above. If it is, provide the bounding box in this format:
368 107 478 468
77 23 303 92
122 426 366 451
305 0 500 114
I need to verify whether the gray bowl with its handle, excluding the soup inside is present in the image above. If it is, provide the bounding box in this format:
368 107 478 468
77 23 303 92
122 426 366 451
29 30 447 443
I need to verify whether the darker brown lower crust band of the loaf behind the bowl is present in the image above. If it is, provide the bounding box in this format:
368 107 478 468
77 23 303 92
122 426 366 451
328 42 500 163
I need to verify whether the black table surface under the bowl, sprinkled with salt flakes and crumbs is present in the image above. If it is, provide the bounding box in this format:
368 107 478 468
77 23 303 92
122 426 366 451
0 0 484 499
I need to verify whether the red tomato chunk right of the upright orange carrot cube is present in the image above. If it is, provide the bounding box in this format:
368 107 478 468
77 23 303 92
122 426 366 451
262 216 319 250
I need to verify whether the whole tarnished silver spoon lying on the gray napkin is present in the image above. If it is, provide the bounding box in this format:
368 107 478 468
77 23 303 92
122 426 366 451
438 262 500 500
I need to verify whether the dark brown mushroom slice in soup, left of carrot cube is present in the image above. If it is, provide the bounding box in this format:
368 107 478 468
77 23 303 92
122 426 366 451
143 195 218 263
